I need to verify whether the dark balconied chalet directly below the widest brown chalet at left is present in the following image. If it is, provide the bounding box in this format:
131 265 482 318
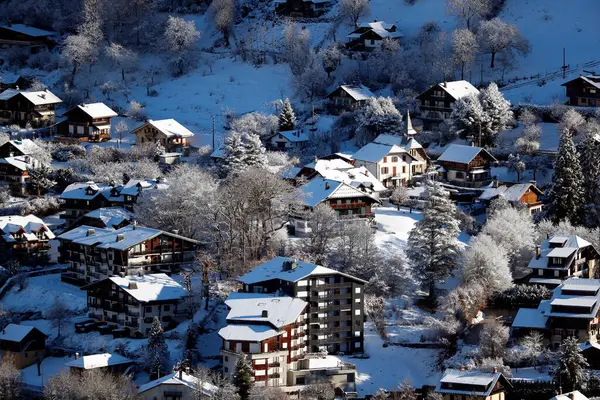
81 274 187 337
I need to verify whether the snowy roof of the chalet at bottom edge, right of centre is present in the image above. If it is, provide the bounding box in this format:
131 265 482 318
435 369 502 396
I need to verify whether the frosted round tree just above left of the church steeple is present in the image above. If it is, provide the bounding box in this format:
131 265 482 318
356 97 404 143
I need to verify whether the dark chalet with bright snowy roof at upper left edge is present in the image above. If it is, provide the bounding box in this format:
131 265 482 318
0 89 62 128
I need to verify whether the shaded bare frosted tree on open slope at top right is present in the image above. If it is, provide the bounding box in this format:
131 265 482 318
477 17 530 68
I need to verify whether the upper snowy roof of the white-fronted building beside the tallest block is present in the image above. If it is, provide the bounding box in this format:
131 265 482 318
225 292 307 328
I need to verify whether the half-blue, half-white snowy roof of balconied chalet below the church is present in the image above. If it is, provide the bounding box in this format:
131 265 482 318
299 178 379 207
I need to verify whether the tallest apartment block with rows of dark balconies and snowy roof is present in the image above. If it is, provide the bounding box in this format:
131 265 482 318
238 257 366 353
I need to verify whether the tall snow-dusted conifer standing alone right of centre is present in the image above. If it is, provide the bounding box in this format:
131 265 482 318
406 182 460 299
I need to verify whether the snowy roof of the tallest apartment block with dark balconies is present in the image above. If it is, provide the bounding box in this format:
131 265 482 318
238 257 366 285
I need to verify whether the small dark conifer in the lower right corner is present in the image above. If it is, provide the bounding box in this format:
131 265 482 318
554 337 589 392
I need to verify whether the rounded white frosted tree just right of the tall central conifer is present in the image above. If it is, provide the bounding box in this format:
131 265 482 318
462 234 512 296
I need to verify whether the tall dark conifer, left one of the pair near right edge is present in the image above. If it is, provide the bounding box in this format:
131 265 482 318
548 131 583 225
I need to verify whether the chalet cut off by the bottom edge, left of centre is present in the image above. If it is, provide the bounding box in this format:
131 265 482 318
136 369 219 400
